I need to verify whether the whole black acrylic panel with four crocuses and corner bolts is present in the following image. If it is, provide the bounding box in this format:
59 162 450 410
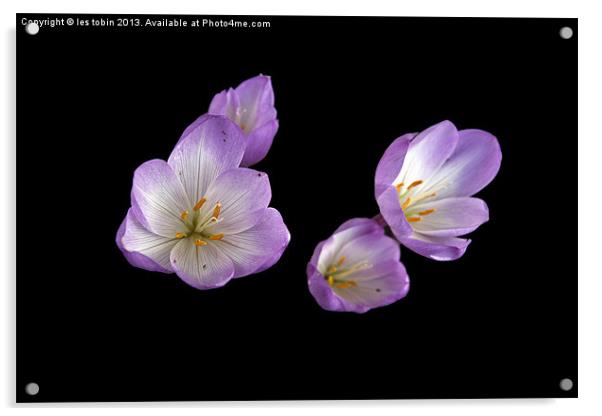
15 14 578 402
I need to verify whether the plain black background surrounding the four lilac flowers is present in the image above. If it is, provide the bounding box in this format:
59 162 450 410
17 15 577 401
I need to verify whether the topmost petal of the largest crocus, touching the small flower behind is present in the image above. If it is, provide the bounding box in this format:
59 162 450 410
167 116 245 204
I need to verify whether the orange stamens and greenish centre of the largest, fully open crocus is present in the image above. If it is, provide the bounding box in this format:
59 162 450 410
175 197 224 247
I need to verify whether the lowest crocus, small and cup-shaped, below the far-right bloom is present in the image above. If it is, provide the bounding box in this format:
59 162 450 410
307 218 410 313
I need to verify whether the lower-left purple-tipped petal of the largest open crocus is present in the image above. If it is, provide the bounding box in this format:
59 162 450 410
115 209 175 273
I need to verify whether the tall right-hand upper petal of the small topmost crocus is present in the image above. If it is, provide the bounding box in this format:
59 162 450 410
236 75 276 128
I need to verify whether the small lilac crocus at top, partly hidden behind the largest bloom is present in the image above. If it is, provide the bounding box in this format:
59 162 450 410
209 75 278 166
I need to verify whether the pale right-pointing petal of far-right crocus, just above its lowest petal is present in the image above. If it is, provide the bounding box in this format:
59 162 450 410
408 197 489 237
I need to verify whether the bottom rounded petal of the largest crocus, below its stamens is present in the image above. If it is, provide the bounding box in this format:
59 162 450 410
170 238 234 290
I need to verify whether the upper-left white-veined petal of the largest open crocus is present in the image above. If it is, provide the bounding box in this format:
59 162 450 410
132 159 190 238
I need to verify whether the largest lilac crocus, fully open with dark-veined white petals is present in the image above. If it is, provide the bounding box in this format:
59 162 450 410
117 116 290 289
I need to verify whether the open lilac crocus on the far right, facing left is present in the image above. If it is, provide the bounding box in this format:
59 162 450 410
375 121 502 260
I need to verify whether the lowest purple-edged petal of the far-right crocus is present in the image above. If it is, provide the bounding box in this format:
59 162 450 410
400 233 470 261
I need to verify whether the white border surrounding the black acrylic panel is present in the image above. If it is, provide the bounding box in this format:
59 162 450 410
0 0 602 416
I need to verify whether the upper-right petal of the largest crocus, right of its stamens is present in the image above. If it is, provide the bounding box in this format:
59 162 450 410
204 168 272 235
